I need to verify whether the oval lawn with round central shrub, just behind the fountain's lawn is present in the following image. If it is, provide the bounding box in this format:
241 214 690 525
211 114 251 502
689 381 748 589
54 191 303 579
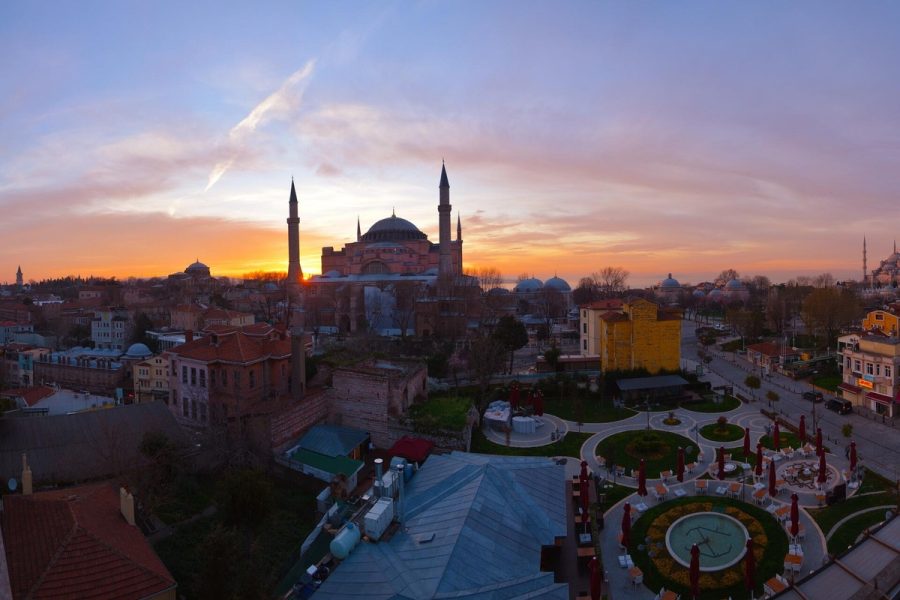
595 429 697 479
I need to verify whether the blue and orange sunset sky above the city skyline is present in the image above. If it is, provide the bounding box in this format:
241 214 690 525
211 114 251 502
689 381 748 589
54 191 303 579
0 0 900 286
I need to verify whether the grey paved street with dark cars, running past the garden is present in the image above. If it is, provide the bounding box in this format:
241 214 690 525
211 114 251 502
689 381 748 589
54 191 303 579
681 321 900 481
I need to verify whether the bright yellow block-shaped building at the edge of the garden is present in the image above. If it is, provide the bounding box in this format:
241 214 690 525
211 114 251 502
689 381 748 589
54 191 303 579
600 299 681 373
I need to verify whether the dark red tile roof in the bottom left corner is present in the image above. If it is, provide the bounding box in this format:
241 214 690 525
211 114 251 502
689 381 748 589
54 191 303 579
0 483 175 600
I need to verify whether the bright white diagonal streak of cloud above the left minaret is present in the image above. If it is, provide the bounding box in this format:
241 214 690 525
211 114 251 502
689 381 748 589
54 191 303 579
203 59 316 192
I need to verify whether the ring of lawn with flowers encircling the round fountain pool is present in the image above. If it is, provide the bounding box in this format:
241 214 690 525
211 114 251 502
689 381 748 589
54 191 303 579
615 497 788 600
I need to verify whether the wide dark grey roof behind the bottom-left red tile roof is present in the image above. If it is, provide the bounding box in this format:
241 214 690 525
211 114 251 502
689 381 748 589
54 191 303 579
0 401 187 483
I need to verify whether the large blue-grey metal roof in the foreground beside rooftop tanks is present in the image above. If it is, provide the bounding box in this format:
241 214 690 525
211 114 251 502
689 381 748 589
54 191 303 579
316 452 568 600
